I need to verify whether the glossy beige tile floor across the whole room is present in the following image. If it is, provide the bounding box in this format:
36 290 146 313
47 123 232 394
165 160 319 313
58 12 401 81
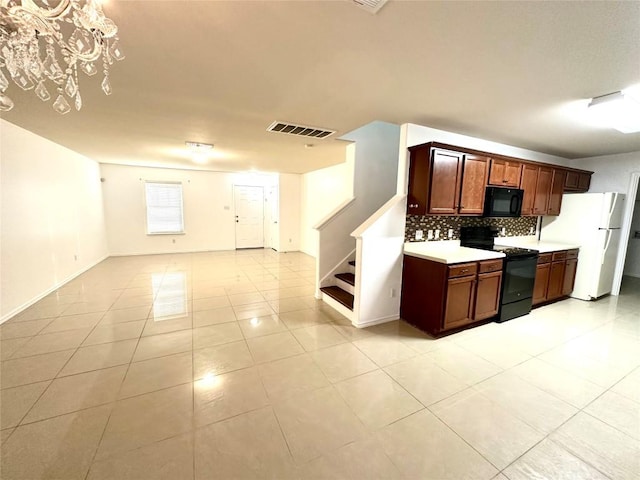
0 250 640 480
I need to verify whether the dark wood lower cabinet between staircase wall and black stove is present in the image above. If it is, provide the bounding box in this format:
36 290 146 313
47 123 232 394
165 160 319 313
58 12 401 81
400 255 502 335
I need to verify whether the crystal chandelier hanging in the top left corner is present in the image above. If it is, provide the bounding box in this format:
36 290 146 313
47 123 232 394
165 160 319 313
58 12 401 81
0 0 124 115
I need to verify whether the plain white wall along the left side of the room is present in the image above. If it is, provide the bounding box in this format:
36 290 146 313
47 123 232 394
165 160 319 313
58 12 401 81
0 120 108 319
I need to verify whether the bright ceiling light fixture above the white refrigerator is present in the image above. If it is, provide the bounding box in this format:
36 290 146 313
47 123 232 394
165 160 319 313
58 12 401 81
589 92 640 133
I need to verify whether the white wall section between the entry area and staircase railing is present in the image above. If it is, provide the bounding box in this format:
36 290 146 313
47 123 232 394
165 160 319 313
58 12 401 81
300 161 353 257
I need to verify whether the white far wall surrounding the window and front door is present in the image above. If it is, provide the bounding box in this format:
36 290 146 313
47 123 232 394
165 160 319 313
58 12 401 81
101 164 300 255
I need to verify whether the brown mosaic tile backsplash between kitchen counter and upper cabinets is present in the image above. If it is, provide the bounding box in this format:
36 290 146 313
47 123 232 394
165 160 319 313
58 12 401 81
404 215 538 242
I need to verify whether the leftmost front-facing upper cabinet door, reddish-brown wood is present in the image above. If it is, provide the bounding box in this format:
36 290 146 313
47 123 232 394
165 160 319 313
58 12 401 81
428 149 464 215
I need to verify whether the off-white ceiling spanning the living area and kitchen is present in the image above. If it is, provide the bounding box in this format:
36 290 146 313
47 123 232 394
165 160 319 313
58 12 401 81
3 0 640 173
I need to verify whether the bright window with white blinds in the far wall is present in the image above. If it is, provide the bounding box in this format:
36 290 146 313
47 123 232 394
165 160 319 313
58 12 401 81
144 182 184 235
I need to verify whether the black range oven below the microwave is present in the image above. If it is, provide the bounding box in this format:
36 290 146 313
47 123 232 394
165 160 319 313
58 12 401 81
460 227 538 322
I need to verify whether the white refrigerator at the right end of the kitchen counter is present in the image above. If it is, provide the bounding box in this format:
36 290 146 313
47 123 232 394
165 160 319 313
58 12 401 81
540 192 625 300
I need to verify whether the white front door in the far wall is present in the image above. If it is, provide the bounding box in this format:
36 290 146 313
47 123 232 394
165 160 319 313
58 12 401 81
234 185 264 248
